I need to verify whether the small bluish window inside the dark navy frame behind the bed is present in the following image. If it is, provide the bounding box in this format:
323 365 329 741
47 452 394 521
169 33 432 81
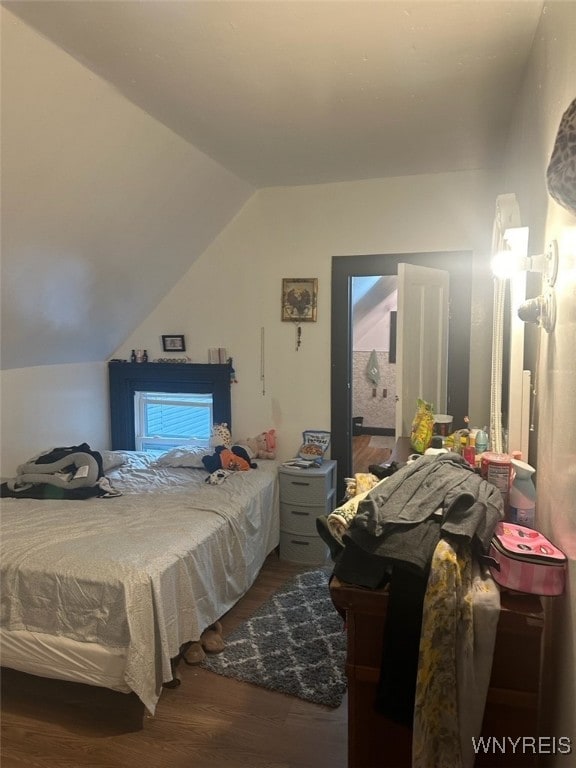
134 391 213 451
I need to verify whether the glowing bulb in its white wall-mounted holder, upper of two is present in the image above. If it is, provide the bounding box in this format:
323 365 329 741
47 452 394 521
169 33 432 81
492 227 558 287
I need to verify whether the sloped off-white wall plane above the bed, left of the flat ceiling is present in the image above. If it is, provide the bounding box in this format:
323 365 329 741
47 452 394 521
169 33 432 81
0 7 253 370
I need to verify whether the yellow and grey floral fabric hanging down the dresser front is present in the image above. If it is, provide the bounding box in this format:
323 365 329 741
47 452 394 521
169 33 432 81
412 539 474 768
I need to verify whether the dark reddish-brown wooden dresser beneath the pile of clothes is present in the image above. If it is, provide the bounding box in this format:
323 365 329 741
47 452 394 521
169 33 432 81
330 578 544 768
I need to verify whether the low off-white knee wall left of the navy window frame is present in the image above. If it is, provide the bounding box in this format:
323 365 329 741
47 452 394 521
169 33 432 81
1 363 110 478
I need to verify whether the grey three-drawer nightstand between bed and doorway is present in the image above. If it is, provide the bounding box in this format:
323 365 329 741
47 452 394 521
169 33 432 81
278 459 336 565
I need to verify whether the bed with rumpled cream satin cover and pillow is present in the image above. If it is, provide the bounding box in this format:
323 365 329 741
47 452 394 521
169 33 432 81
0 451 279 714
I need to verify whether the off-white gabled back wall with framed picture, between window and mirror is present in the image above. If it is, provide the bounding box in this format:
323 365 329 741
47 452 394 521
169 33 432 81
115 172 496 458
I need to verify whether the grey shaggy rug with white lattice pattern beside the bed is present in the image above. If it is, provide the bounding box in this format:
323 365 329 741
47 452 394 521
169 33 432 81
202 569 346 708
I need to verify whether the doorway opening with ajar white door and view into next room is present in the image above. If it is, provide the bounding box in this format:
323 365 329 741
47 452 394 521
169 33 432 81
352 262 450 472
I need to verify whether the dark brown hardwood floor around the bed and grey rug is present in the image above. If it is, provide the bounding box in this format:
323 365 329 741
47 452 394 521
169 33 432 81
0 554 347 768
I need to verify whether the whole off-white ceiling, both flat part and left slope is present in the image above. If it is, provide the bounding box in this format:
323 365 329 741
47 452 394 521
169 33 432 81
2 0 543 368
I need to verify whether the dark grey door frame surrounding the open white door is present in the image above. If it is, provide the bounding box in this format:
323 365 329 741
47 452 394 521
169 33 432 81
331 251 472 498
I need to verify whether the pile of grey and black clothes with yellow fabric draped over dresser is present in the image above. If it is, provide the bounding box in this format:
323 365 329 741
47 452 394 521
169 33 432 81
326 453 504 768
